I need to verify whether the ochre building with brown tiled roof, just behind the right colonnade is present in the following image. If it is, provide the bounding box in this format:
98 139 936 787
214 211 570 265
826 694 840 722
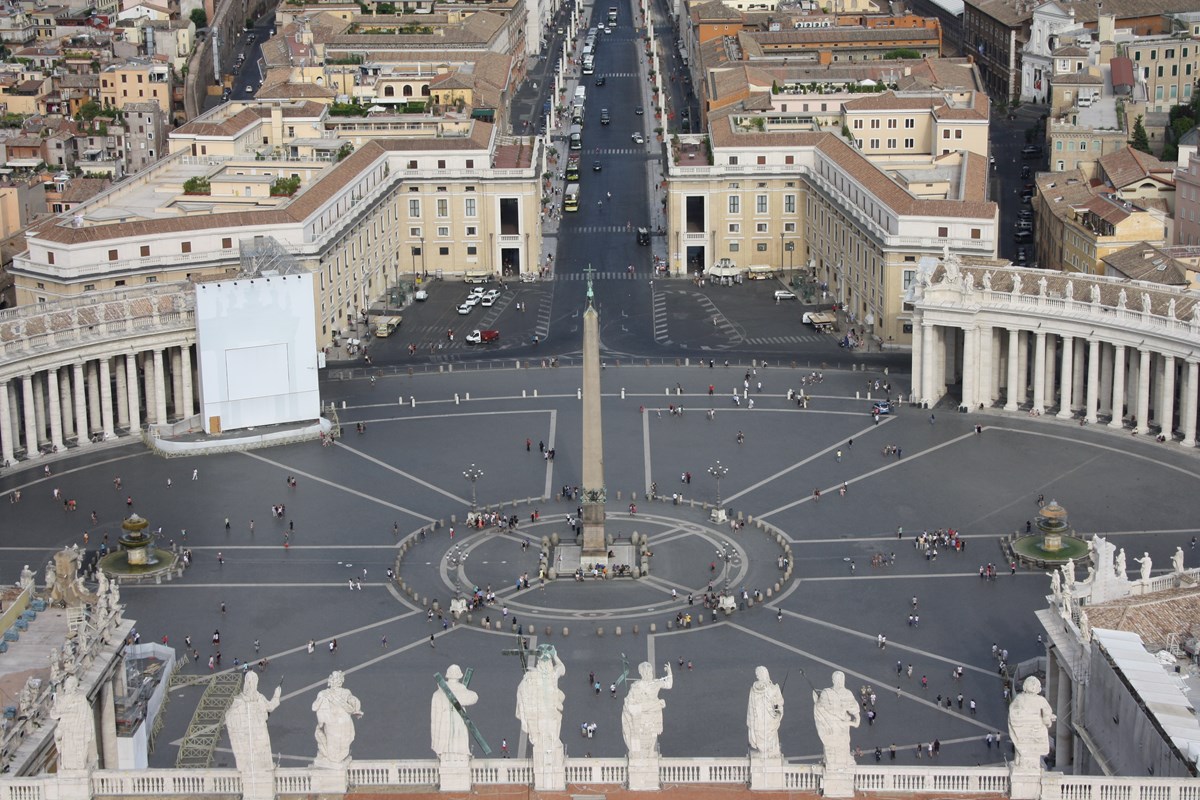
1033 170 1171 275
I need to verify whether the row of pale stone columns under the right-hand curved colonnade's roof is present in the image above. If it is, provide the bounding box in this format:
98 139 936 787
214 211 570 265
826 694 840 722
913 319 1200 447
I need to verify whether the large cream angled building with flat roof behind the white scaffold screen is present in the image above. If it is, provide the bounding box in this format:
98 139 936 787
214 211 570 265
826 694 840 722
12 102 542 347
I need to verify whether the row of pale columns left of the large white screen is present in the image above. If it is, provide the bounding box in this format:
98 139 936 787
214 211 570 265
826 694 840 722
0 344 198 465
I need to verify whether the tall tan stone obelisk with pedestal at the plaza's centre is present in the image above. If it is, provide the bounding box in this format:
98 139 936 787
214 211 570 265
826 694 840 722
580 265 608 566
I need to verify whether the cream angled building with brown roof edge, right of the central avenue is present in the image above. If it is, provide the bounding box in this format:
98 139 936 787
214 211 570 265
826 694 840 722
667 107 1000 344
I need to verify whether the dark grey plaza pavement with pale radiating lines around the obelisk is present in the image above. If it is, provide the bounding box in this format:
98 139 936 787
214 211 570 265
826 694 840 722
0 366 1200 766
